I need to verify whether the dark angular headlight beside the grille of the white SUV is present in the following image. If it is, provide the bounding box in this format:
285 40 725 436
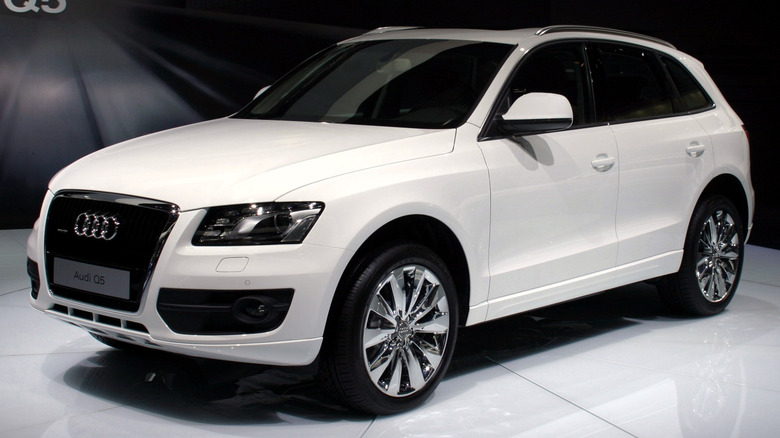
192 202 325 245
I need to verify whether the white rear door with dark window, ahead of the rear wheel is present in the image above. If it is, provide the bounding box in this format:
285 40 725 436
588 43 713 268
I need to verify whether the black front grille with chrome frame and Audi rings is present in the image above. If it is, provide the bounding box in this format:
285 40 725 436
45 192 179 312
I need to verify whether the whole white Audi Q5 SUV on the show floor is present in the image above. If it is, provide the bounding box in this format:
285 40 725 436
28 26 754 413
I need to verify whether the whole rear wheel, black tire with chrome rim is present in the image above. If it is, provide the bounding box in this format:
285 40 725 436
658 196 745 316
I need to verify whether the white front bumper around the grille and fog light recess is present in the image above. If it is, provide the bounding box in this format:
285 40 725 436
28 202 350 366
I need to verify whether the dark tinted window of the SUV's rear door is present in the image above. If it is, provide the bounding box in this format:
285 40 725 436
588 43 675 122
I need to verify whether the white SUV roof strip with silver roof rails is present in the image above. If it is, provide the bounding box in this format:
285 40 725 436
344 25 674 49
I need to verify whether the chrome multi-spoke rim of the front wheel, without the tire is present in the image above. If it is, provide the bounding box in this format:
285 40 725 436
362 265 451 397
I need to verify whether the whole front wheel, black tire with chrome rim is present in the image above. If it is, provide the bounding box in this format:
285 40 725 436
320 243 458 414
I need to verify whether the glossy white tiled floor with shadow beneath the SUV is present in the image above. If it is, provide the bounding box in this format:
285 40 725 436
0 230 780 437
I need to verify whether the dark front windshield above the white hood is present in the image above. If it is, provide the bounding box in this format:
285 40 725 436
236 40 512 128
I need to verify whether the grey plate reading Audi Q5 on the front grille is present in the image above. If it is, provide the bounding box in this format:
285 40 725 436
54 257 130 300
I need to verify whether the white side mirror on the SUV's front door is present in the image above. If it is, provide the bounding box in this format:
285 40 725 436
498 93 574 135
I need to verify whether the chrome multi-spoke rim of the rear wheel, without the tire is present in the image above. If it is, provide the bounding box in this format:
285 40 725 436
696 209 741 303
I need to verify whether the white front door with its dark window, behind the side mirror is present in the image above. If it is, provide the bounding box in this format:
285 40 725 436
479 43 619 318
